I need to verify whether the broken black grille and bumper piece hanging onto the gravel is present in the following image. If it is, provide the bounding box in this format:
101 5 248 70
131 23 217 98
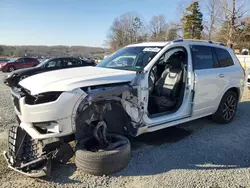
3 126 59 177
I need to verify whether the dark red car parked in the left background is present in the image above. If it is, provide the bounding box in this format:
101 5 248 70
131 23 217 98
0 57 40 72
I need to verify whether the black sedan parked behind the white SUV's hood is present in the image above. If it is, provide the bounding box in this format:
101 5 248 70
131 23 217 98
4 57 96 87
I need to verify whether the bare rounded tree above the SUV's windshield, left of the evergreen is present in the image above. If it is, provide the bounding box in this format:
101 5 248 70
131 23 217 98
149 14 167 40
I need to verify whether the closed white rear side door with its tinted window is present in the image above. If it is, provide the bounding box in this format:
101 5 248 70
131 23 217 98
191 45 228 116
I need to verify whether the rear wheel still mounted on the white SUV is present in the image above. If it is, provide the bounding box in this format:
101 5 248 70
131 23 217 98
212 91 238 124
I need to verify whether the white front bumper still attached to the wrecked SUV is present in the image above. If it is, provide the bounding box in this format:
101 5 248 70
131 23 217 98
11 89 85 140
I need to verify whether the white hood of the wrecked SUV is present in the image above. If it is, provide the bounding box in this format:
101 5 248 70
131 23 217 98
19 67 136 95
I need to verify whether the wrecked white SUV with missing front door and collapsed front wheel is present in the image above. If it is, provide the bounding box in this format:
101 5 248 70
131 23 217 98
4 40 245 177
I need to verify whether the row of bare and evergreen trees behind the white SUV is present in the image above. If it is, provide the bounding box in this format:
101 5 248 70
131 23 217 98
106 0 250 51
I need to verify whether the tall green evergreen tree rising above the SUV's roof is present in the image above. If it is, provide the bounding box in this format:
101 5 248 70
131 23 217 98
181 1 203 39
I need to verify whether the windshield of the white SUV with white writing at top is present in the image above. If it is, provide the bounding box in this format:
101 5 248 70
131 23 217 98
97 46 162 71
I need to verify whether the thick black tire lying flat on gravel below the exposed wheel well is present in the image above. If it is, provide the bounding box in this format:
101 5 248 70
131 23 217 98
75 135 131 176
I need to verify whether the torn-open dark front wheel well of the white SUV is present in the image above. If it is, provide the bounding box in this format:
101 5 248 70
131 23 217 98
75 83 143 139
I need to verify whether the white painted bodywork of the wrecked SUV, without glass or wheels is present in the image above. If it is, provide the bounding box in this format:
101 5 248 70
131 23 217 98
13 42 245 139
